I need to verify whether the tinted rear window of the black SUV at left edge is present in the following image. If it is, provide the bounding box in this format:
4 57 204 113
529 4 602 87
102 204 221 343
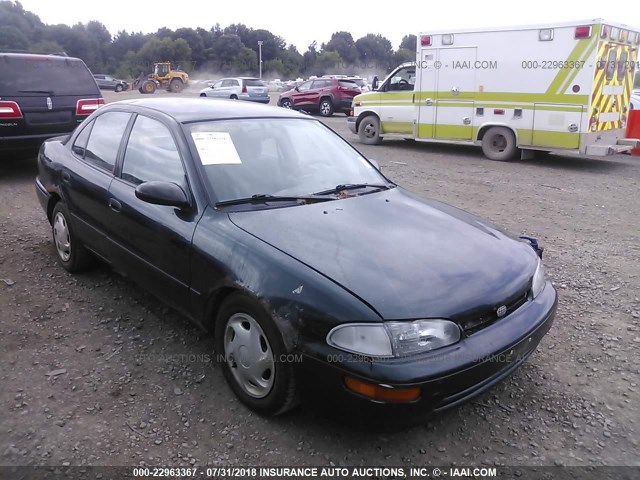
0 54 99 97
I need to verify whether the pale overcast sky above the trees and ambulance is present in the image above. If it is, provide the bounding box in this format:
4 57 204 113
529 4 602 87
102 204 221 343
13 0 640 52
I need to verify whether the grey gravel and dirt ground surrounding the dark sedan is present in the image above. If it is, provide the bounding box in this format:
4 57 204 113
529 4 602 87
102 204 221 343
0 86 640 466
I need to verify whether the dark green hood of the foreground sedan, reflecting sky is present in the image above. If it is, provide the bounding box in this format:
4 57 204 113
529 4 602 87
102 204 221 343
229 188 537 320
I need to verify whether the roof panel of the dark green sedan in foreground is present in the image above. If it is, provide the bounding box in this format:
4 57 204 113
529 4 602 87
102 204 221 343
107 97 310 123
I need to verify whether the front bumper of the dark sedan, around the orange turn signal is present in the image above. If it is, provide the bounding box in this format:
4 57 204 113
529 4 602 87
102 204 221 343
300 282 557 413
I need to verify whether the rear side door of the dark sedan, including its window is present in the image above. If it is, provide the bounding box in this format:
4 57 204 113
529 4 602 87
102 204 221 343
60 112 131 256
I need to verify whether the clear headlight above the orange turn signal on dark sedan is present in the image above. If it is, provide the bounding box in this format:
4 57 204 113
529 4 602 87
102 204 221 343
327 320 460 357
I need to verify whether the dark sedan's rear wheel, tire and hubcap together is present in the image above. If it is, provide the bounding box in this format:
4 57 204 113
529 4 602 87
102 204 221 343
51 202 93 273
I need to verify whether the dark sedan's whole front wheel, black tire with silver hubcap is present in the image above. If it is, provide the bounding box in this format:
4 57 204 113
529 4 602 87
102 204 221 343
215 293 298 416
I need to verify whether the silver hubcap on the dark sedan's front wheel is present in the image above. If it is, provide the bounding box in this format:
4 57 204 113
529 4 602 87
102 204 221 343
224 313 275 398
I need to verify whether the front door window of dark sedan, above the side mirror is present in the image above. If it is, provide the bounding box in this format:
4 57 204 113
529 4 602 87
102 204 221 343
122 115 185 186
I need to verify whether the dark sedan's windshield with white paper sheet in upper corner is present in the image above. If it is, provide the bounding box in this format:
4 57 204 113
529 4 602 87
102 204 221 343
188 118 393 204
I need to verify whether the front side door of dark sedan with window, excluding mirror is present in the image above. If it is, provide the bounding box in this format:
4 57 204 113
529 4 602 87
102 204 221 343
109 115 199 314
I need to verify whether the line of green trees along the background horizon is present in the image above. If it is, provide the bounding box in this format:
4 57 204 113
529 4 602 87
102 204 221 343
0 0 416 79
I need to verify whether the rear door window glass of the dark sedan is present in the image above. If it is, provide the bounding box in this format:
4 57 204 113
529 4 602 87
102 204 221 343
84 112 131 172
